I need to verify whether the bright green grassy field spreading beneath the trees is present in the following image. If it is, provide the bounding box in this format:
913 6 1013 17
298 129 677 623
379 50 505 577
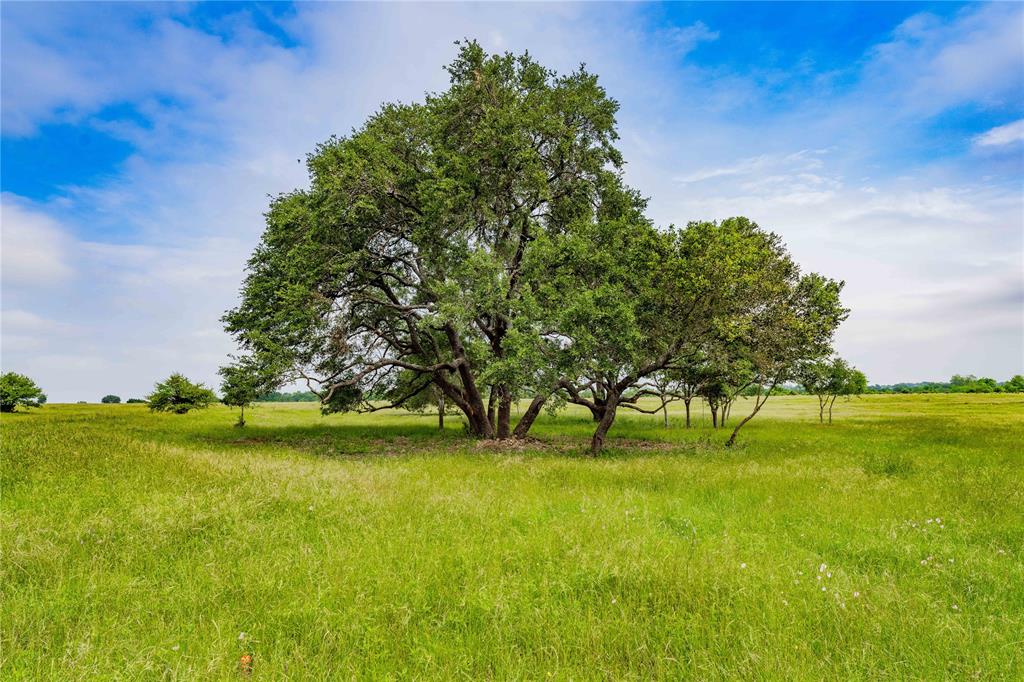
0 395 1024 680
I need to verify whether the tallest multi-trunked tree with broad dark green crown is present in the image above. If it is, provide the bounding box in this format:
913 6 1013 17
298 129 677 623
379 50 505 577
225 42 633 437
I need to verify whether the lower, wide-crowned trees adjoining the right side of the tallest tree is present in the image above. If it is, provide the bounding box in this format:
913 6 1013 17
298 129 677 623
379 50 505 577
539 218 848 453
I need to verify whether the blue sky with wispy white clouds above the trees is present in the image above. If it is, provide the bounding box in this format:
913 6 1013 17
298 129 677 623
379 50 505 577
0 3 1024 400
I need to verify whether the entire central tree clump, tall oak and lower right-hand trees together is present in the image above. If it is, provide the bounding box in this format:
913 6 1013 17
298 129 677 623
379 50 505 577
224 42 846 453
